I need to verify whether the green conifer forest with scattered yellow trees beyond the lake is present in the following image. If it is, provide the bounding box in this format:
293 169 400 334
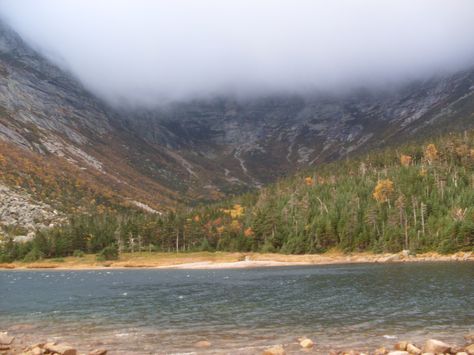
0 131 474 261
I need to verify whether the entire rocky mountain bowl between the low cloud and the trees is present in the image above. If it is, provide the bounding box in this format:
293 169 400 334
0 20 474 235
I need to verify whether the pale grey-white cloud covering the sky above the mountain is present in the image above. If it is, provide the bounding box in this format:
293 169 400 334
0 0 474 105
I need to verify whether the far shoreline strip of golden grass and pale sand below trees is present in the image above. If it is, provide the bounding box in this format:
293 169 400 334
0 251 474 271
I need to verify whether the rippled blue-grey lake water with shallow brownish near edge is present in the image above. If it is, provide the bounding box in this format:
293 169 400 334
0 263 474 354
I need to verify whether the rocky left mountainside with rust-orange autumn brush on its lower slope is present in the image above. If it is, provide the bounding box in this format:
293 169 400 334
0 23 230 228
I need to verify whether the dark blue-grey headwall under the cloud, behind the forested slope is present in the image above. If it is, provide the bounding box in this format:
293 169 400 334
122 71 474 186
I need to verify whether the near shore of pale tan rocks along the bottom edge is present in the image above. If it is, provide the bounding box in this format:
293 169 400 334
0 332 474 355
